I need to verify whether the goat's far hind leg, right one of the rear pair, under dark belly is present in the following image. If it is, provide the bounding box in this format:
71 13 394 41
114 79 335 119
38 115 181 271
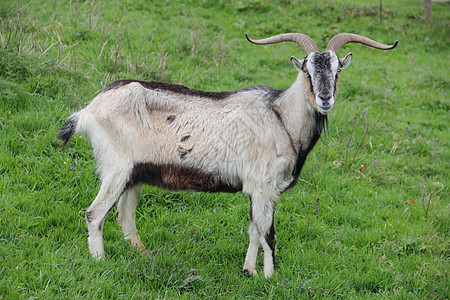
116 184 148 254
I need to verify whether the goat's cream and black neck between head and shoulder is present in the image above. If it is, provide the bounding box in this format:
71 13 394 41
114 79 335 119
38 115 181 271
275 73 323 151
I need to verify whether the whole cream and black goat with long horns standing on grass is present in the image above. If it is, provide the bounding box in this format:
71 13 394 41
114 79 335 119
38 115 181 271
58 33 397 278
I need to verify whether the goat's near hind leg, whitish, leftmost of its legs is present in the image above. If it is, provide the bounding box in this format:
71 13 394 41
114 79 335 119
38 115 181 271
86 170 126 259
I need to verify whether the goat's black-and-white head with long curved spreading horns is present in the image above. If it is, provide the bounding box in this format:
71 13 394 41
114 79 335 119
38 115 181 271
245 33 398 115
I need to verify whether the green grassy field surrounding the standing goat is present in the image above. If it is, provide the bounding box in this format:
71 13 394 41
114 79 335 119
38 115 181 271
0 0 450 299
